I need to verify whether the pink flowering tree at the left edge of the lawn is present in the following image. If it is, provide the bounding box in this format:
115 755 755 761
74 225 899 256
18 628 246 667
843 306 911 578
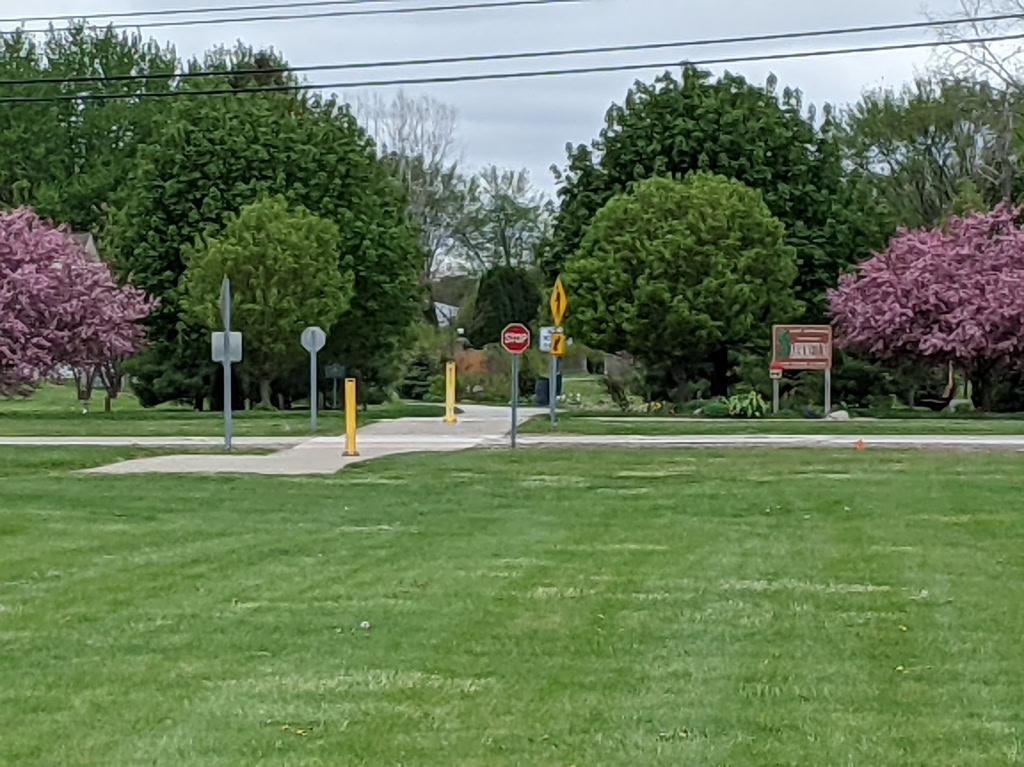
0 203 157 409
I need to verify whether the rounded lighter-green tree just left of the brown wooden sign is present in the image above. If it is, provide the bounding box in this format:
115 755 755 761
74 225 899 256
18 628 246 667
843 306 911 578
564 173 801 394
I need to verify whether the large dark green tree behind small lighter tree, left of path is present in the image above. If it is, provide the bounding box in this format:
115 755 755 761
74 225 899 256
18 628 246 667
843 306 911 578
108 93 423 404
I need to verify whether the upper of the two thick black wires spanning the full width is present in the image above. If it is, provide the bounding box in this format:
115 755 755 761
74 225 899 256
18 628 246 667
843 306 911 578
0 11 1024 86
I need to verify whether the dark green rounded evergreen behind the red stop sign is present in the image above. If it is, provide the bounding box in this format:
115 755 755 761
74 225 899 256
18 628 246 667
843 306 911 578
467 266 541 346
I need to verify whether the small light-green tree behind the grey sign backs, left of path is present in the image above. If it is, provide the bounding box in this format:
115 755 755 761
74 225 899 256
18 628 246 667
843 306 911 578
184 197 354 407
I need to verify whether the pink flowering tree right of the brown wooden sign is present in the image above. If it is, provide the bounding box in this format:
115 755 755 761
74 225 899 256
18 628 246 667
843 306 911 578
828 205 1024 410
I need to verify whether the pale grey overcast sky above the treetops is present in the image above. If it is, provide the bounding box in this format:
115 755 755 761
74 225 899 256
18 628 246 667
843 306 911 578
9 0 957 190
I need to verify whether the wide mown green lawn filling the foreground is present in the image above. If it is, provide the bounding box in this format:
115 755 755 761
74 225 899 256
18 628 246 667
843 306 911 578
0 449 1024 767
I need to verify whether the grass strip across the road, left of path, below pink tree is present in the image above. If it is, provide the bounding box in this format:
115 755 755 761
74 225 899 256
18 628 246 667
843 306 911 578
0 386 444 436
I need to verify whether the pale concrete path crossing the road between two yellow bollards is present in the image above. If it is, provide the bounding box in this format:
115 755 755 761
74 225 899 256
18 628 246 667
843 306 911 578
86 404 542 476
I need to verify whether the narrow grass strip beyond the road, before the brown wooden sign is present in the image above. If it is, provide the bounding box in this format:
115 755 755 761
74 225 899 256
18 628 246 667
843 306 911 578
522 413 1024 436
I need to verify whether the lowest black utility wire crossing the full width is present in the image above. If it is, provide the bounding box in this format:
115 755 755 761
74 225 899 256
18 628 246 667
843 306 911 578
0 33 1024 104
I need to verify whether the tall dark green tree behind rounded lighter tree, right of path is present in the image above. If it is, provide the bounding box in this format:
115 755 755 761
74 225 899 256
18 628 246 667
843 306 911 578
543 67 884 314
